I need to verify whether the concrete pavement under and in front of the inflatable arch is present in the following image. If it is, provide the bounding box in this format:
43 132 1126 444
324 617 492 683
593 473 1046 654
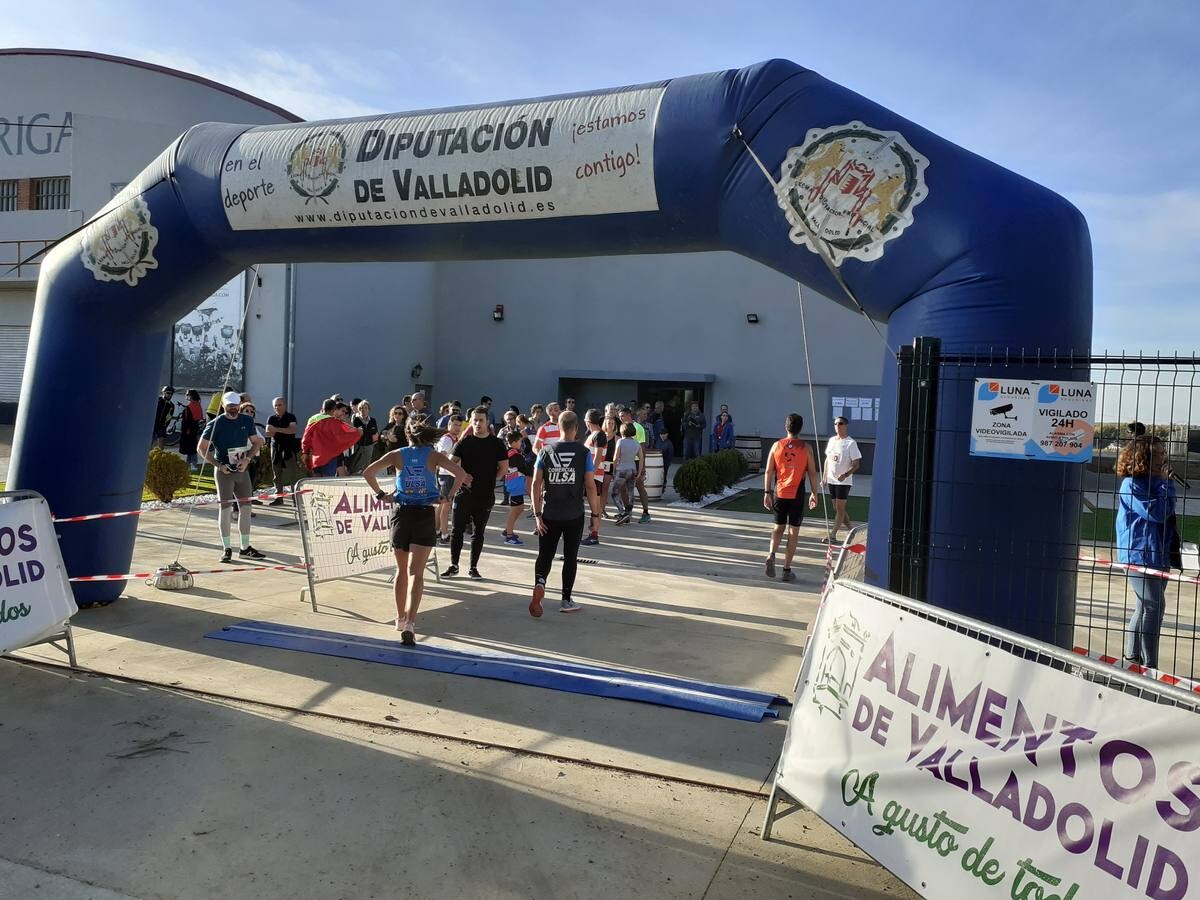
0 482 907 898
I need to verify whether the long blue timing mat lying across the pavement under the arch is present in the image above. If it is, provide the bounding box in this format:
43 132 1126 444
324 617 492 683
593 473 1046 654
205 622 787 722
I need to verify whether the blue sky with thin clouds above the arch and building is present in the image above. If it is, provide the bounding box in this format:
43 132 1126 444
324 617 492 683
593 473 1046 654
0 0 1200 353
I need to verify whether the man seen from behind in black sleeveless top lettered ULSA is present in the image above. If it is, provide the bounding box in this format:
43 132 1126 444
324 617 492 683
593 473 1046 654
529 412 600 619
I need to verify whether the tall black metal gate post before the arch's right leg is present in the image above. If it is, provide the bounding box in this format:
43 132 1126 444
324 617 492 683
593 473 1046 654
888 337 942 600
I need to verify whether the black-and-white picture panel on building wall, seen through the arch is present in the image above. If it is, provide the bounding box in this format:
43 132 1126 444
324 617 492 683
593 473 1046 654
172 272 246 391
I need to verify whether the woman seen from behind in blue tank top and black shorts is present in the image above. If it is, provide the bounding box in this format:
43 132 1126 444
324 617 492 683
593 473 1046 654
362 418 470 646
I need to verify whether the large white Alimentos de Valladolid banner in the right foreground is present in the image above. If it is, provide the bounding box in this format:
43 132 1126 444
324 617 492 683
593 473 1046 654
778 582 1200 900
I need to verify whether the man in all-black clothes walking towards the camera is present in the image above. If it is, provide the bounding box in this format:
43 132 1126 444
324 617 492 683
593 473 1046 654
442 407 509 578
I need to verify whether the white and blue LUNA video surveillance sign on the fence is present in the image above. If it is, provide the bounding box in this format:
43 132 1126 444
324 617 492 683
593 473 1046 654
971 378 1096 462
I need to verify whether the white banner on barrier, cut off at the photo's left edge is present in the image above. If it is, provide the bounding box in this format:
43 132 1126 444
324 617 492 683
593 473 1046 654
0 497 78 654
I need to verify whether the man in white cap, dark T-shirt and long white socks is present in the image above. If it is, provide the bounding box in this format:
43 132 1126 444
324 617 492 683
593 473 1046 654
197 391 264 563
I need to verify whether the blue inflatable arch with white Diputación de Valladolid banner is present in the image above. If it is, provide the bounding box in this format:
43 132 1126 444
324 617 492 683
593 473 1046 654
10 60 1091 637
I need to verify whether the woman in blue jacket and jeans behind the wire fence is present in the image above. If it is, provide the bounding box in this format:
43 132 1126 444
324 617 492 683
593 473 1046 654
1116 434 1175 668
